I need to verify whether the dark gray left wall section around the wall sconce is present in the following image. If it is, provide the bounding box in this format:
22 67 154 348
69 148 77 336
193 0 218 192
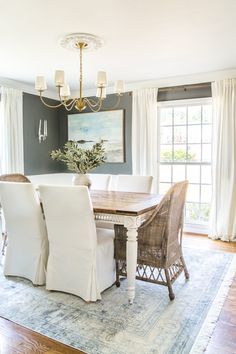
23 93 61 175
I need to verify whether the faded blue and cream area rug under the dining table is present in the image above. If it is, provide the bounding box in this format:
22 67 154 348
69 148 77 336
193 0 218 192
0 248 236 354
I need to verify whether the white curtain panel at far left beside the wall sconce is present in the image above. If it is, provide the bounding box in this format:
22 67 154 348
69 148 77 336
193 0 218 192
0 87 24 174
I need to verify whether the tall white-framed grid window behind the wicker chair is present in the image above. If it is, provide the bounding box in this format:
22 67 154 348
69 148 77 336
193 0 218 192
159 99 212 232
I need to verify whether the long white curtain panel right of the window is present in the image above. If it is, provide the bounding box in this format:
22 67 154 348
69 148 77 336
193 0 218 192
209 79 236 241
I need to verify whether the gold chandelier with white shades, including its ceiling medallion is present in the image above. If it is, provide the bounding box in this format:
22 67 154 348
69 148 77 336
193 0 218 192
35 33 124 112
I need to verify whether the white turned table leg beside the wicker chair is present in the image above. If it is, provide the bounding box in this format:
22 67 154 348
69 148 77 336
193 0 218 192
124 217 139 304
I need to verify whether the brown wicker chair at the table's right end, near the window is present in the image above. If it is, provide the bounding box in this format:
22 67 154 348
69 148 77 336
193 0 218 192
114 181 189 300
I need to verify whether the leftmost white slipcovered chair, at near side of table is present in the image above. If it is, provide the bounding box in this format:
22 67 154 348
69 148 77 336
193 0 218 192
0 182 48 285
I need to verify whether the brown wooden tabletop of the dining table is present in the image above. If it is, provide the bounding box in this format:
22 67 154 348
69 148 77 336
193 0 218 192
90 190 161 216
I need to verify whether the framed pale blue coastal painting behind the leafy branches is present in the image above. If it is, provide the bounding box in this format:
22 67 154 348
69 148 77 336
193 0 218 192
68 110 124 163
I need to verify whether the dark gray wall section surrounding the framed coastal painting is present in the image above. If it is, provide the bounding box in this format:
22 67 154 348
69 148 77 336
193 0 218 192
59 93 132 174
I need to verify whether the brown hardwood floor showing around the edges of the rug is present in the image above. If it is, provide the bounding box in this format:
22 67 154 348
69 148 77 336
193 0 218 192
0 234 236 354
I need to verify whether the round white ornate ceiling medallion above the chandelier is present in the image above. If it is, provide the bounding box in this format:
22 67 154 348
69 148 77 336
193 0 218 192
59 33 104 52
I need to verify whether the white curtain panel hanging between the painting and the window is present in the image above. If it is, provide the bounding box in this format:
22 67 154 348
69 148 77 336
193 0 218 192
132 88 158 192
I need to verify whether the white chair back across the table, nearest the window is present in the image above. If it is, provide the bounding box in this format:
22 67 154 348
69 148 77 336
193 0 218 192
116 175 153 193
